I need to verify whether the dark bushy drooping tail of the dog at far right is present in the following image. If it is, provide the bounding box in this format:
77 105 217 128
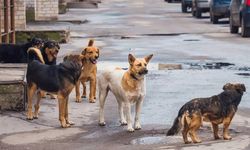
167 107 185 136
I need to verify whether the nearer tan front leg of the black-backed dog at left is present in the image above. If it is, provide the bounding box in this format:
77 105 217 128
57 94 70 128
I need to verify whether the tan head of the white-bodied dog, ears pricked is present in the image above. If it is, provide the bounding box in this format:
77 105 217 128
128 54 153 78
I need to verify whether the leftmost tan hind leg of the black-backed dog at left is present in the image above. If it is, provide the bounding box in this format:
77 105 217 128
27 84 37 120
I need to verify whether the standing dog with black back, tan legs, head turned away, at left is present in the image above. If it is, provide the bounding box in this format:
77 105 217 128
26 55 84 128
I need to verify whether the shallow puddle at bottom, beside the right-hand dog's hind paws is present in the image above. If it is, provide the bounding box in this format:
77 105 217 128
130 135 182 145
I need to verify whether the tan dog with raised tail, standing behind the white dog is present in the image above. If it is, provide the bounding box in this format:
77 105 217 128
76 40 99 103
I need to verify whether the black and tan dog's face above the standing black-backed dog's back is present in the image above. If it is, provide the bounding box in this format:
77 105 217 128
43 40 60 62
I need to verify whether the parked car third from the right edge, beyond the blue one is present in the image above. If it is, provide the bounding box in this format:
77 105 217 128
192 0 209 18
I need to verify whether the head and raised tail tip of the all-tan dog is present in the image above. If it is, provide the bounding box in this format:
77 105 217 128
82 39 100 64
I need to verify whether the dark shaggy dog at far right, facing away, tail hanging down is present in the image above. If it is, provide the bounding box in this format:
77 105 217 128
167 83 246 144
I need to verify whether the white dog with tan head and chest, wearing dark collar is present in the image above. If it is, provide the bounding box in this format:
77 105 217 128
98 54 153 132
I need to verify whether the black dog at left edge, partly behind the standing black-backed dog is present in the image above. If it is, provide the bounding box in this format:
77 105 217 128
0 38 60 65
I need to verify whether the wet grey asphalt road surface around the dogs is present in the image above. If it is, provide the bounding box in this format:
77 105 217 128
0 0 250 150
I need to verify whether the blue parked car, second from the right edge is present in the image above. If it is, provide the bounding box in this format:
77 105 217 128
209 0 231 24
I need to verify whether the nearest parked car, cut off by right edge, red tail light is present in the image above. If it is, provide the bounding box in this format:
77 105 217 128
229 0 250 37
